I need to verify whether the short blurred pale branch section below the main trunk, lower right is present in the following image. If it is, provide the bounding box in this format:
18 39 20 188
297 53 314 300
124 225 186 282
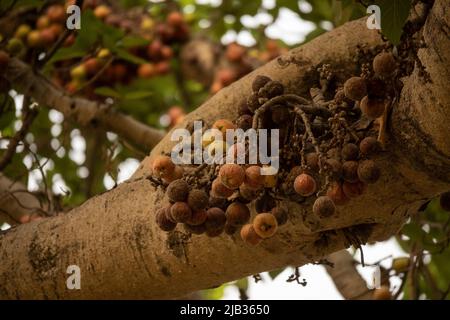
325 250 372 300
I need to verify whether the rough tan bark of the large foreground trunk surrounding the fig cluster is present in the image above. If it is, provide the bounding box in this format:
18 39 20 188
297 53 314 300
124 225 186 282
0 1 450 299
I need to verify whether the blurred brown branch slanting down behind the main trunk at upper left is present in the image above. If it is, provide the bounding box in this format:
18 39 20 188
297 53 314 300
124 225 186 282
4 58 163 151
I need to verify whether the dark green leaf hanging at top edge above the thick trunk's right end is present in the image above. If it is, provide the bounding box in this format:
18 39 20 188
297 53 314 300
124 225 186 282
375 0 411 45
